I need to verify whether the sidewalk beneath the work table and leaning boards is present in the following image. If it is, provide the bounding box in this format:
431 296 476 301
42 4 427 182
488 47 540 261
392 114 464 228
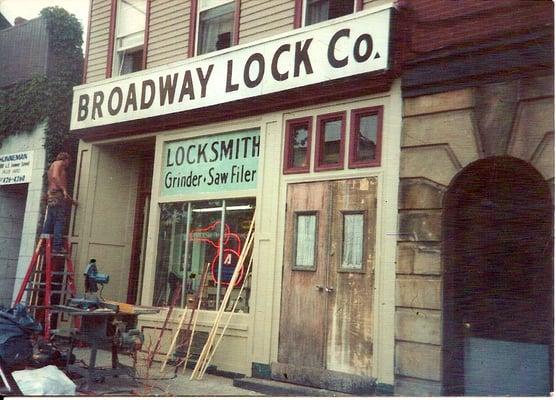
68 348 263 397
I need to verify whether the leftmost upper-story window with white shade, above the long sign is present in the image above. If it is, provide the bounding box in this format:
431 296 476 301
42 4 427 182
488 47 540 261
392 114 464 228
112 0 147 76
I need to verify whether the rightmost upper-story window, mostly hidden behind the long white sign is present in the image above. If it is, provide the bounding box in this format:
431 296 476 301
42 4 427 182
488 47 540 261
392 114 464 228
296 0 362 28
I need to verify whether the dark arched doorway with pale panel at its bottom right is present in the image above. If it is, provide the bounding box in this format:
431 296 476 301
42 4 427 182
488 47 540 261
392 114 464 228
442 157 554 395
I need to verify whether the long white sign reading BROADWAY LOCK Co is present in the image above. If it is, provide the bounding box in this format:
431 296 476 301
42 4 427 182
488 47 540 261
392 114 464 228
71 8 391 130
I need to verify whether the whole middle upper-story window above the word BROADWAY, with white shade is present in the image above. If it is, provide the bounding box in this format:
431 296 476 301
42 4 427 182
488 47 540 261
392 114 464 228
197 0 236 55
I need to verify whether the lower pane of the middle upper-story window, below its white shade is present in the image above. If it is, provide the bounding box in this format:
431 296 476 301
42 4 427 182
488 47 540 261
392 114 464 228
198 2 235 54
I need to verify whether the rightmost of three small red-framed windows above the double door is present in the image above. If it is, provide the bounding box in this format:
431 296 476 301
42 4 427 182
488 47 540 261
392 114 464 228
348 106 383 168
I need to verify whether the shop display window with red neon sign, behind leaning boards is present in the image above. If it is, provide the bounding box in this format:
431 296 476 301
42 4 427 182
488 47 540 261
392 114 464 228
154 199 255 312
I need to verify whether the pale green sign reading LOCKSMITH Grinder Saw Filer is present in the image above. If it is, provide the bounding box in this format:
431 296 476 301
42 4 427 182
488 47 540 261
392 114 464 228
161 129 260 196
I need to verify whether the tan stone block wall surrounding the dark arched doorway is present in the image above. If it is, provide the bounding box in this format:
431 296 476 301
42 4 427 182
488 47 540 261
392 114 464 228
394 77 554 396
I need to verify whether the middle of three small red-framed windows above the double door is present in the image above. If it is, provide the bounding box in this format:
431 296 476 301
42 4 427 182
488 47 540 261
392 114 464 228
315 112 346 171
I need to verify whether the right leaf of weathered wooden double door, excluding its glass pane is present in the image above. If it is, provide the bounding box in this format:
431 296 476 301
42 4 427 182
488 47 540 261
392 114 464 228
326 178 377 376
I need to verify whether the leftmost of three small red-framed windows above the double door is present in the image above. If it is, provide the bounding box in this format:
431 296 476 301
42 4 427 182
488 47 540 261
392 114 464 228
284 117 313 174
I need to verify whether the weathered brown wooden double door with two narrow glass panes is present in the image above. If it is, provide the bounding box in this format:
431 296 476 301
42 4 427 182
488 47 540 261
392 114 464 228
278 178 377 384
